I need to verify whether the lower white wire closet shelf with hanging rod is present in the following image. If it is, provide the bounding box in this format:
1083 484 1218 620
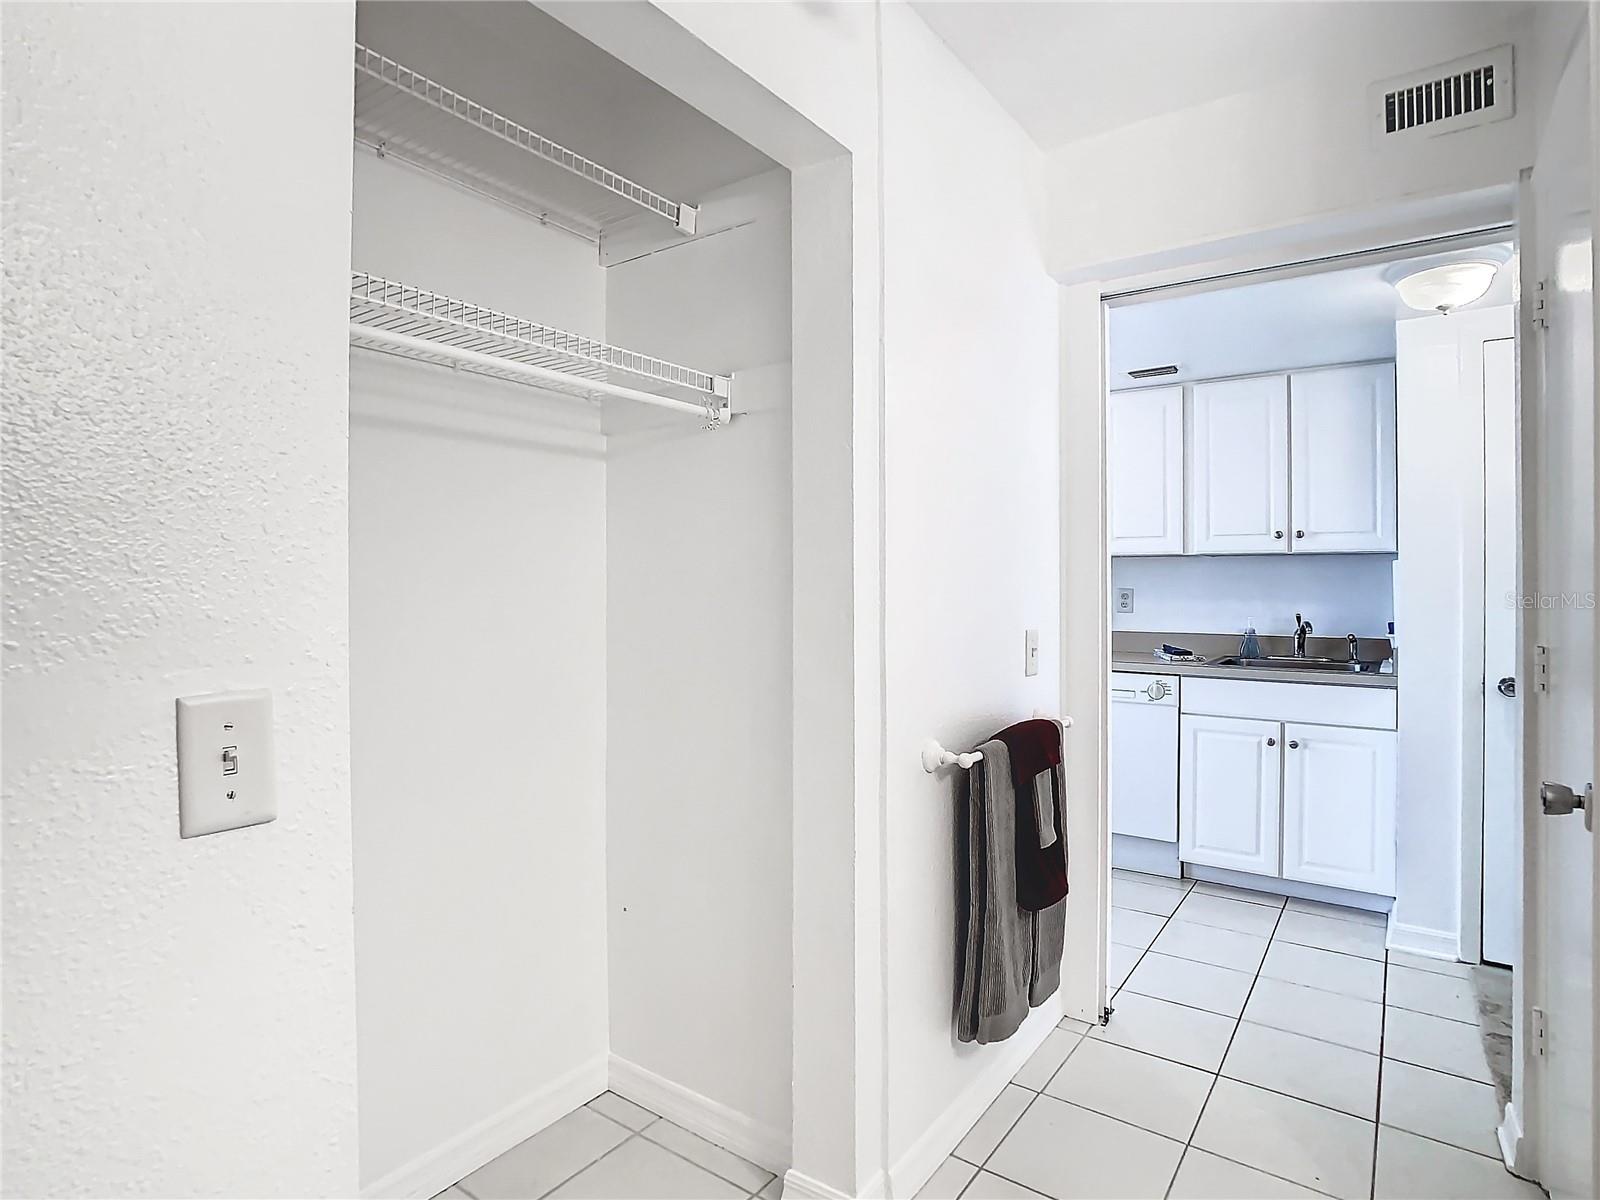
350 270 733 426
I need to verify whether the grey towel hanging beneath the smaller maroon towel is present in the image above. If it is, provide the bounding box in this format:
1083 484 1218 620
955 726 1067 1042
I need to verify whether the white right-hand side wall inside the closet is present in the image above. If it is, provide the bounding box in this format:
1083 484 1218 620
606 171 794 1170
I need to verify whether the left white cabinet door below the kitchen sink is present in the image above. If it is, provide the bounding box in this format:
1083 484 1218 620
1178 715 1283 875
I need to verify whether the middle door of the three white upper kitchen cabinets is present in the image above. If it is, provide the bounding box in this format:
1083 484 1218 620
1189 374 1290 554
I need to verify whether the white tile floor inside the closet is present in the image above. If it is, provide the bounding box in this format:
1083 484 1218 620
437 1091 779 1200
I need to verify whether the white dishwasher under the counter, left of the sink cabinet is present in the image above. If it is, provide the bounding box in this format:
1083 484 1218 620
1110 670 1178 866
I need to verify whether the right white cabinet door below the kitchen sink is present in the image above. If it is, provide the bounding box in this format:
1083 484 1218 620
1283 725 1395 896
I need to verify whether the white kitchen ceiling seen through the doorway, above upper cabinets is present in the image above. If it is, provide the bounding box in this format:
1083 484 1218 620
1110 248 1514 389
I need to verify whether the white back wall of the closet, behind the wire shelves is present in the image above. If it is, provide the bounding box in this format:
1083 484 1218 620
350 152 606 1194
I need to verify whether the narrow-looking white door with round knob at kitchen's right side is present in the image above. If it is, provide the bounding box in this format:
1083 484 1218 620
1482 338 1528 966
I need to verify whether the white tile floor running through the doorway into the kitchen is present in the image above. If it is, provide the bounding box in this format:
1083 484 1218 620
918 872 1541 1200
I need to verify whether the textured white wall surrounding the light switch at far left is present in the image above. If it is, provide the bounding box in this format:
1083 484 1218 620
3 3 357 1197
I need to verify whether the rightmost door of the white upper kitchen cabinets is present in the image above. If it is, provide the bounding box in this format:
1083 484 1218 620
1290 363 1395 552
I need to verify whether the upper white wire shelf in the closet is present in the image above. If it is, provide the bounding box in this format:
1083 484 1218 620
355 43 699 242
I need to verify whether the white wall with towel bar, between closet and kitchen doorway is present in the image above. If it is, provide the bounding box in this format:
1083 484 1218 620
883 5 1059 1194
